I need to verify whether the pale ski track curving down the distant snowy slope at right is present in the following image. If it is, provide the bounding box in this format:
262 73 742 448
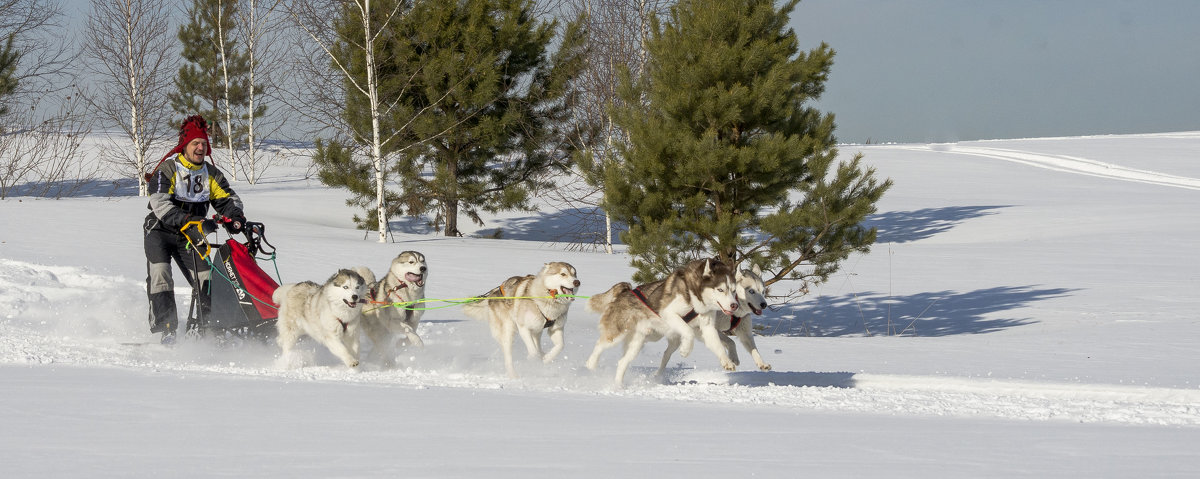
882 144 1200 190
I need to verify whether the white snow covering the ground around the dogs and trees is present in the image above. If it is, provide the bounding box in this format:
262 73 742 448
0 132 1200 478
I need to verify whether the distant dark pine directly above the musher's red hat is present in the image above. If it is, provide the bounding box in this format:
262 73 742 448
170 0 265 148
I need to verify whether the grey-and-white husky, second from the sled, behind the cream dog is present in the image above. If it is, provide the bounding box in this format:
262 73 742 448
354 251 428 366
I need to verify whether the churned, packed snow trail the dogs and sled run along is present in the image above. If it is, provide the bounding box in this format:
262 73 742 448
0 259 1200 426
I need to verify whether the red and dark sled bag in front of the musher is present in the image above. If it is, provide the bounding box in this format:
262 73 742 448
209 239 280 339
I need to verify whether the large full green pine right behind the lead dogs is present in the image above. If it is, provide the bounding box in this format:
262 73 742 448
605 0 890 289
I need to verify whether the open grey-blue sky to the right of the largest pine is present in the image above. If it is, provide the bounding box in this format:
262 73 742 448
791 0 1200 143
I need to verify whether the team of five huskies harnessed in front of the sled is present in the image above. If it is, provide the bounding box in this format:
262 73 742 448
272 251 770 387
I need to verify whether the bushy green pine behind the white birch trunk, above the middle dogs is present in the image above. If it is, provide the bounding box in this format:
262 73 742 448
318 0 583 235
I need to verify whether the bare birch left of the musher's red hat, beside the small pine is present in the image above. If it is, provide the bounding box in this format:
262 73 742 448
84 0 179 196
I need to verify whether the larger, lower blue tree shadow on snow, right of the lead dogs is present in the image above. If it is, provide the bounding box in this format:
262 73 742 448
755 286 1078 337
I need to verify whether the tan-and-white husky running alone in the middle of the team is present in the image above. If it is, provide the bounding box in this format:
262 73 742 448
463 262 580 377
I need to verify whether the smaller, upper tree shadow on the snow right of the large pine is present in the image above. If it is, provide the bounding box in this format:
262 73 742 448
863 205 1012 244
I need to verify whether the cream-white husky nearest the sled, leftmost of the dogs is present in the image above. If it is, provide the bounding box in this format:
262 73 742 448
271 269 366 367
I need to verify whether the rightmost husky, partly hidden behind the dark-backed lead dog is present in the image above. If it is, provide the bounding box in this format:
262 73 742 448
658 264 770 375
